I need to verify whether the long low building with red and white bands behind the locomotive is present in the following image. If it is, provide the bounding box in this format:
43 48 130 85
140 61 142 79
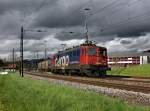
108 52 150 67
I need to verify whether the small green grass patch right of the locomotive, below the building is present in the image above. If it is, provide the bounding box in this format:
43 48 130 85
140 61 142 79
108 65 150 77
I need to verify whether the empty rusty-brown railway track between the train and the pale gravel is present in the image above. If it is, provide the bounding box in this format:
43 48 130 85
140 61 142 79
25 72 150 94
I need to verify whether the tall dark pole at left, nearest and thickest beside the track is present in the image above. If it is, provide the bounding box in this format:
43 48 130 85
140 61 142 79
20 26 24 77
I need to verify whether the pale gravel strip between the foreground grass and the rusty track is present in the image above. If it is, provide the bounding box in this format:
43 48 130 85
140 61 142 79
27 75 150 106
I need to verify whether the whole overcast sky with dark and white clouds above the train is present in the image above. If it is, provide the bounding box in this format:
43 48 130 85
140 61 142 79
0 0 150 58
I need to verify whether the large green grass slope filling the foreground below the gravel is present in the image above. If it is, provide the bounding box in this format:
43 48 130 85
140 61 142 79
0 74 150 111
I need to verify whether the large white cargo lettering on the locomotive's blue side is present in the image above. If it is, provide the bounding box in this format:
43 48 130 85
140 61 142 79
55 55 69 67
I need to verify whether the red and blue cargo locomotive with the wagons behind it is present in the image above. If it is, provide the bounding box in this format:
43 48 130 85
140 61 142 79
38 41 110 76
